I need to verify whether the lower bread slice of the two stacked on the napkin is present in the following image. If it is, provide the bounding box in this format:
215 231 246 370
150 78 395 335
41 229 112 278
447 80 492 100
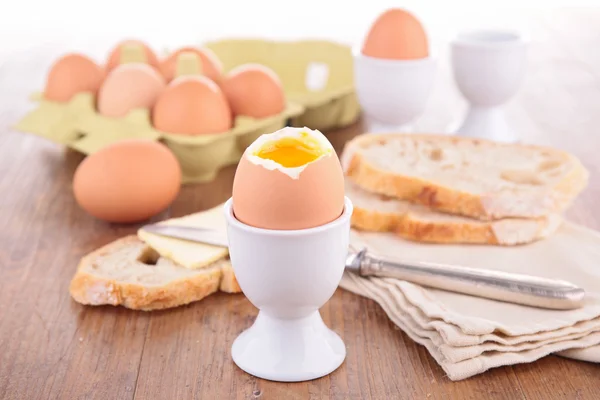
346 178 562 245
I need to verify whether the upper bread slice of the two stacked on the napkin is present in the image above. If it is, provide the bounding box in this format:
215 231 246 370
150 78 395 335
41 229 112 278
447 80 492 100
342 134 588 220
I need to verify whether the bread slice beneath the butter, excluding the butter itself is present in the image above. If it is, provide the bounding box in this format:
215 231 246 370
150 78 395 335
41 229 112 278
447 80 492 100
70 235 241 311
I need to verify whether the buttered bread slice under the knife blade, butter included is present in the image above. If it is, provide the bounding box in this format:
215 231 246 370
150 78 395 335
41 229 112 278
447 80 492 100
70 207 241 311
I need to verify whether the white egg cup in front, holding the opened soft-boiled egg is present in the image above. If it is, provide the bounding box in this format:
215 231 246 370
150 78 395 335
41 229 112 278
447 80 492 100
225 198 352 382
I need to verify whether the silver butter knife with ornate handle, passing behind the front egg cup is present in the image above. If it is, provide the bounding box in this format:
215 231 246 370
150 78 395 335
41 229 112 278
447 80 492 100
141 224 585 310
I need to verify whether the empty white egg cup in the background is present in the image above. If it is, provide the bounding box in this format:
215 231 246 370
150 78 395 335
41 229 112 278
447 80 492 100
452 30 527 142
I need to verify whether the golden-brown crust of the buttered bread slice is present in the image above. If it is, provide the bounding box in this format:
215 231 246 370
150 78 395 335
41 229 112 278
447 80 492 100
69 235 241 311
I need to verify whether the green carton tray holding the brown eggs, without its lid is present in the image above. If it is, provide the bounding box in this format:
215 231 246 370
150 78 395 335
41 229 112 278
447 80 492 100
15 93 304 184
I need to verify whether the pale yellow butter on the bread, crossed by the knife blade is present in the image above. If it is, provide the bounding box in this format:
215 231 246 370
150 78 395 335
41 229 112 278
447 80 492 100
137 205 229 269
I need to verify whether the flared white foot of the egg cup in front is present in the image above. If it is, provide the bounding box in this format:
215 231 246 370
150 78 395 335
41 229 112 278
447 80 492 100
231 311 346 382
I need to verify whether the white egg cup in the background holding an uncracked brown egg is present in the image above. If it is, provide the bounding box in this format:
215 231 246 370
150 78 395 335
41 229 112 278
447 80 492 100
353 48 436 133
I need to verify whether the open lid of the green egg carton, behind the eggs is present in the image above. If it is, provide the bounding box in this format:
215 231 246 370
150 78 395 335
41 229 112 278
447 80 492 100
203 39 360 131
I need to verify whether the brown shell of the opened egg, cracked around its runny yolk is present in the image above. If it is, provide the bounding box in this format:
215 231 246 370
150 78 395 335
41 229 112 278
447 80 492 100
232 128 344 230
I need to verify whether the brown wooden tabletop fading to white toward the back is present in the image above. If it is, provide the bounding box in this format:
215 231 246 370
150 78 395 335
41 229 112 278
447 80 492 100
0 10 600 400
